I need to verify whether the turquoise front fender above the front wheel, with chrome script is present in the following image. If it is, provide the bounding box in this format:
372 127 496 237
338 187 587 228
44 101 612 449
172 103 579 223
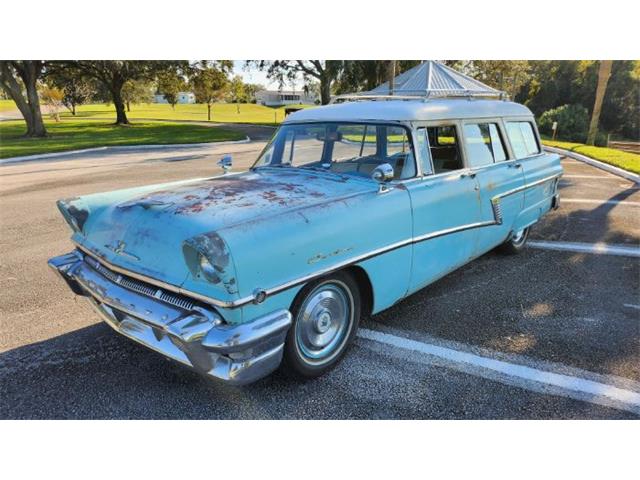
219 187 412 320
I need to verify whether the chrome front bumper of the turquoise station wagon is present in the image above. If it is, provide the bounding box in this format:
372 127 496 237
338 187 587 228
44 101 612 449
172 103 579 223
49 251 291 385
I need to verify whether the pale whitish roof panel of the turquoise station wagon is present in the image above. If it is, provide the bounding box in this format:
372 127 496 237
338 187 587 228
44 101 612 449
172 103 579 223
284 98 533 123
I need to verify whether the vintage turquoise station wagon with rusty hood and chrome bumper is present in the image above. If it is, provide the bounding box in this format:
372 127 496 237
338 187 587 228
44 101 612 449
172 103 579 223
49 98 562 384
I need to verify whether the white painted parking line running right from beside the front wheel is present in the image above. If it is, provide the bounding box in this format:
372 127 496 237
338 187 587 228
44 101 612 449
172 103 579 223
358 329 640 413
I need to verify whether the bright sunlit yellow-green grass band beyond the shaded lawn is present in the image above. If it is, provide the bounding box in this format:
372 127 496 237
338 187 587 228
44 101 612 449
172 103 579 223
62 103 312 125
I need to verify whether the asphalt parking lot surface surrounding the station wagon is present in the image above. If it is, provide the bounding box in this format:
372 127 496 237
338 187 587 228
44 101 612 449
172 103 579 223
0 142 640 419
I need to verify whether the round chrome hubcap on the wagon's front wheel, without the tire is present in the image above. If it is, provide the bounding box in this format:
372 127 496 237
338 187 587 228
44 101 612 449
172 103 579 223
296 282 353 363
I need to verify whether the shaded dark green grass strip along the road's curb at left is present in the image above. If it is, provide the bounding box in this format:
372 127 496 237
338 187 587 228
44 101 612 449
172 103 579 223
0 118 245 158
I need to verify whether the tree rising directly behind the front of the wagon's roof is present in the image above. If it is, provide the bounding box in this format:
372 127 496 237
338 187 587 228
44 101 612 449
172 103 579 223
253 60 344 105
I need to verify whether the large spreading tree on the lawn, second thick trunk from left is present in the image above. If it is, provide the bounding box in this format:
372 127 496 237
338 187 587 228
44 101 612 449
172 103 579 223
58 60 188 125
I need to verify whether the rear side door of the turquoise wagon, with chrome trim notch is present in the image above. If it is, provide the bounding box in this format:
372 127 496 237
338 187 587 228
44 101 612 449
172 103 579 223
463 119 524 256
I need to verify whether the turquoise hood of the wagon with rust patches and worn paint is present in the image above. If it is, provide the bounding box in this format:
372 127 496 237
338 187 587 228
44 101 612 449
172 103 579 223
65 168 376 300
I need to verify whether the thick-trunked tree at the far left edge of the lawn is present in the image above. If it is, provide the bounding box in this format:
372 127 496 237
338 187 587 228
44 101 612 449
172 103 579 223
0 60 47 137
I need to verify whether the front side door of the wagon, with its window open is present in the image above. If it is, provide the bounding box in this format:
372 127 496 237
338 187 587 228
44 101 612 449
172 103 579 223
405 123 480 292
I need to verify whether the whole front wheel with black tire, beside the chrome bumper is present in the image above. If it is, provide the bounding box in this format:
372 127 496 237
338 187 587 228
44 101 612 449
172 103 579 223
282 272 360 378
